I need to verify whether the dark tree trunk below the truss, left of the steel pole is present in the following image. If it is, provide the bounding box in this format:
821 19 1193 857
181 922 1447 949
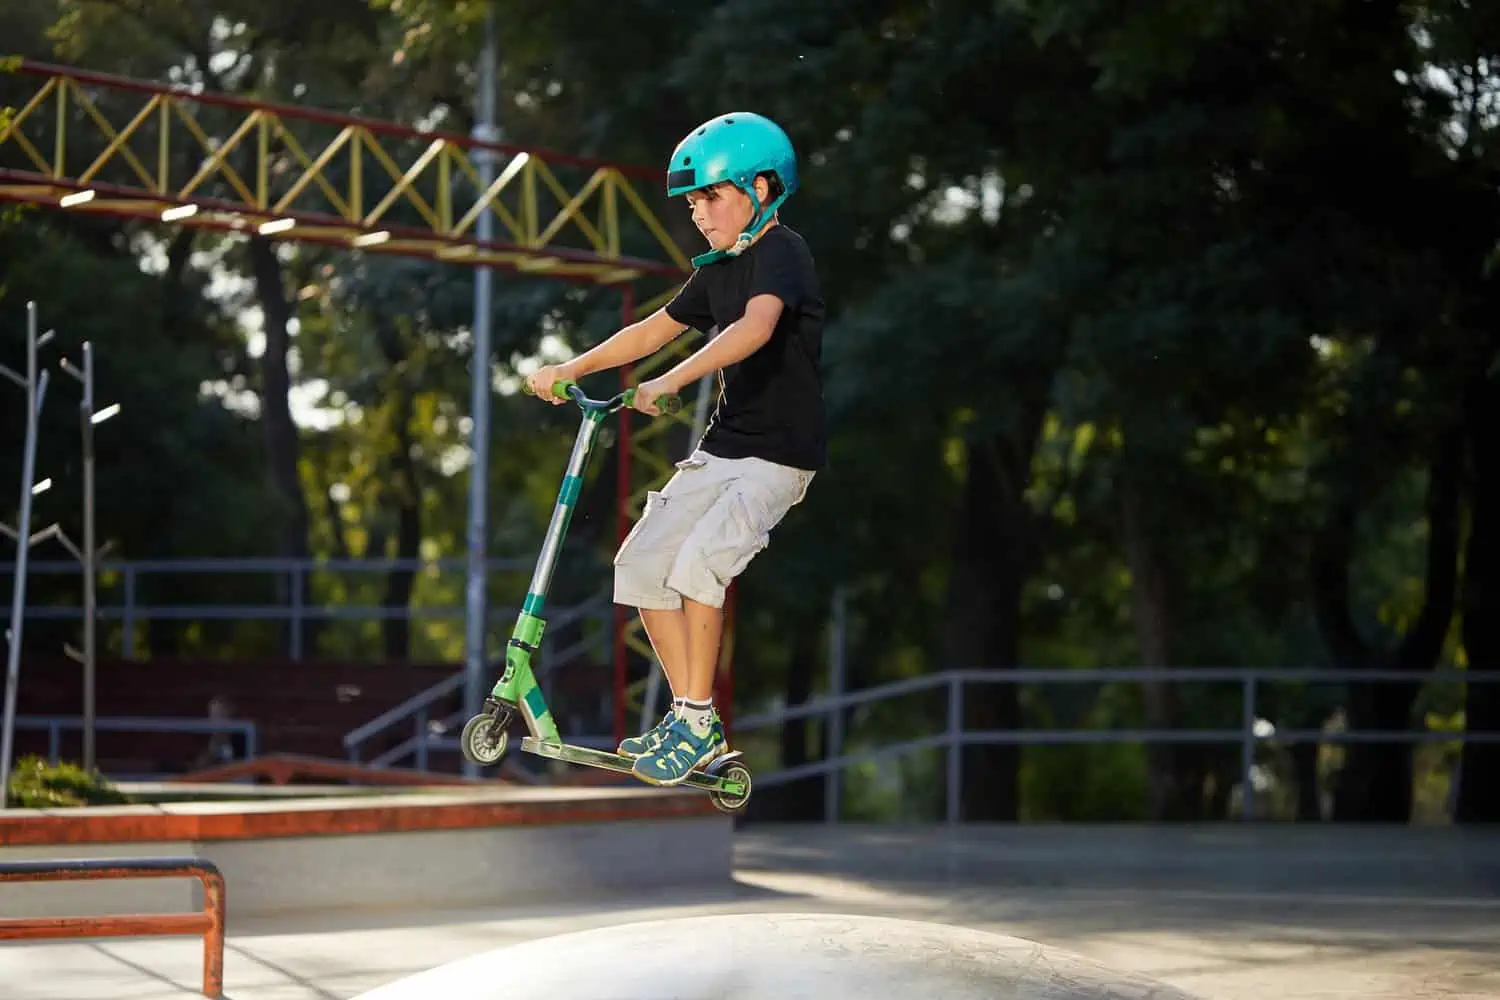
249 235 315 654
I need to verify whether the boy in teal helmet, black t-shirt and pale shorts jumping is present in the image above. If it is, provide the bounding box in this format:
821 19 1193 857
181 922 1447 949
527 112 827 784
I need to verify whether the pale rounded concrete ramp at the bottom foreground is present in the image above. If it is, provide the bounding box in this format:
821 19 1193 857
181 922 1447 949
356 913 1197 1000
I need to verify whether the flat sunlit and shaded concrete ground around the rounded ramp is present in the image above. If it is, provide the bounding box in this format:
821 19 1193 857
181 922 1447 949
0 826 1500 1000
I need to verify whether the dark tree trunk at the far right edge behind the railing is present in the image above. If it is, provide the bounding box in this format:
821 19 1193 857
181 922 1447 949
1454 379 1500 823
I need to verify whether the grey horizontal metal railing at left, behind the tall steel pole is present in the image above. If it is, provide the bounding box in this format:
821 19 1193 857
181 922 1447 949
0 558 606 660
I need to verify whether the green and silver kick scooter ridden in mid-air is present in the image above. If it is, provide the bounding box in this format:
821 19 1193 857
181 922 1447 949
459 382 750 813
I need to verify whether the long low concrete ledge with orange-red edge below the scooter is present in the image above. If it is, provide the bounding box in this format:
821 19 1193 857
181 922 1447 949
0 787 734 925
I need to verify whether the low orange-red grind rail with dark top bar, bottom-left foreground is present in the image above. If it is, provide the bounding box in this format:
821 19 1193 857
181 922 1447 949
0 858 225 1000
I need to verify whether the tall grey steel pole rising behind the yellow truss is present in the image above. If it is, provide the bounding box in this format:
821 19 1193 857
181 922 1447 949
464 4 500 777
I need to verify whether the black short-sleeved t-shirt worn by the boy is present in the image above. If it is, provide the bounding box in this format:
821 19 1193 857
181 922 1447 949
666 223 828 471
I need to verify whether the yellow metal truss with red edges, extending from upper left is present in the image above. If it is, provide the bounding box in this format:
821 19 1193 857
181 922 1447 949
0 60 690 285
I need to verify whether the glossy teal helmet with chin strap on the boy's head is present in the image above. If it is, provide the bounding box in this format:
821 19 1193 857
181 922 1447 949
666 111 797 267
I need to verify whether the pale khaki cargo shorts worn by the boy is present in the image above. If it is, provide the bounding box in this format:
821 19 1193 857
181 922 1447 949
615 450 813 610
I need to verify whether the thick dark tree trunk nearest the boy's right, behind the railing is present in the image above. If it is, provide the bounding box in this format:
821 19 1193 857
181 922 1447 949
945 434 1040 822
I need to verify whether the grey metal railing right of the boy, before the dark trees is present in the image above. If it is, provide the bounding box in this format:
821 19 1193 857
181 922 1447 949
735 667 1500 823
